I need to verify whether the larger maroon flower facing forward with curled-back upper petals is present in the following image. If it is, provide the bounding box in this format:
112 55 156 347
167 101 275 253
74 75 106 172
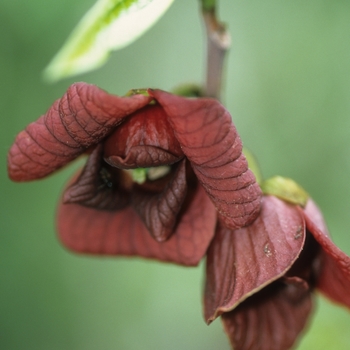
8 83 261 265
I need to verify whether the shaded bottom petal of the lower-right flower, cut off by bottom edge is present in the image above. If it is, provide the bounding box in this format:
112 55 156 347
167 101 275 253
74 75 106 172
222 277 312 350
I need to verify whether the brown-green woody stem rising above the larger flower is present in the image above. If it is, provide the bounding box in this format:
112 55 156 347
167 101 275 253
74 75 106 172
201 0 231 99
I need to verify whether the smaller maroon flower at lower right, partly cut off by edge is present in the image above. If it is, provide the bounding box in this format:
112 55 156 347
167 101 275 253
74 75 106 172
204 196 350 350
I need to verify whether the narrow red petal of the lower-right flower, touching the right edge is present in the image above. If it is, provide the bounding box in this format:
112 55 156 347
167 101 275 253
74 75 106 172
300 199 350 308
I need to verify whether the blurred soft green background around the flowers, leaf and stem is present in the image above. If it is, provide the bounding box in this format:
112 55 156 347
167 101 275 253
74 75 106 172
0 0 350 350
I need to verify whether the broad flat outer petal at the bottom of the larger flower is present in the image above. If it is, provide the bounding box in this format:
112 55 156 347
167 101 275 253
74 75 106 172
58 180 216 266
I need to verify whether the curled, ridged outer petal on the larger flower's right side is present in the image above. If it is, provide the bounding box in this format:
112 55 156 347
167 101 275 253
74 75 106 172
150 90 261 229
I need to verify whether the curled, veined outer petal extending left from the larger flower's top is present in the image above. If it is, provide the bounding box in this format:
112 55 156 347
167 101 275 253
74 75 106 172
8 83 150 181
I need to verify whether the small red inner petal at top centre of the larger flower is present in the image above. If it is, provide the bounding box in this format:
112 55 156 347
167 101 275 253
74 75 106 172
104 104 184 169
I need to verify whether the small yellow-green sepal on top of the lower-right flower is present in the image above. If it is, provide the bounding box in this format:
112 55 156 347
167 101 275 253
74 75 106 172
260 176 309 207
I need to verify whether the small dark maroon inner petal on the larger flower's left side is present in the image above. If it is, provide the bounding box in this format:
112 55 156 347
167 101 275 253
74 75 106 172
63 145 132 210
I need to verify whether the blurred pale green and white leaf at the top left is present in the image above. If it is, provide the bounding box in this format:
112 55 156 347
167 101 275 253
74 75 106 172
44 0 174 81
